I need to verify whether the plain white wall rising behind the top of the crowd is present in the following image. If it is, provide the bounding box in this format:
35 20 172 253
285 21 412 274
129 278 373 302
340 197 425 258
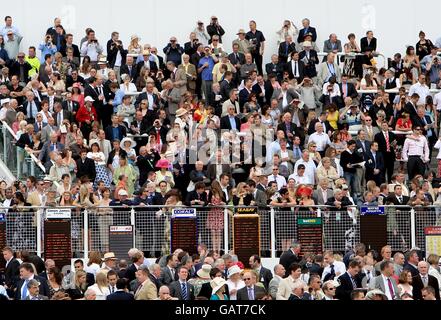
6 0 441 61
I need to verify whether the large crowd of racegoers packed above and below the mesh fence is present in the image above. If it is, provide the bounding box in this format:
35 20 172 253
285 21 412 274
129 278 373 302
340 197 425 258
0 16 441 300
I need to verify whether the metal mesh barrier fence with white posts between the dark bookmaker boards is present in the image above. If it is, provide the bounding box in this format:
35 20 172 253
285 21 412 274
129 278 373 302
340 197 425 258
0 206 441 258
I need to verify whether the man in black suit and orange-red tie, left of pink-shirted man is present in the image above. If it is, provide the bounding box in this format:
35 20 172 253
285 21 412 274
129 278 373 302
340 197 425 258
374 121 397 183
